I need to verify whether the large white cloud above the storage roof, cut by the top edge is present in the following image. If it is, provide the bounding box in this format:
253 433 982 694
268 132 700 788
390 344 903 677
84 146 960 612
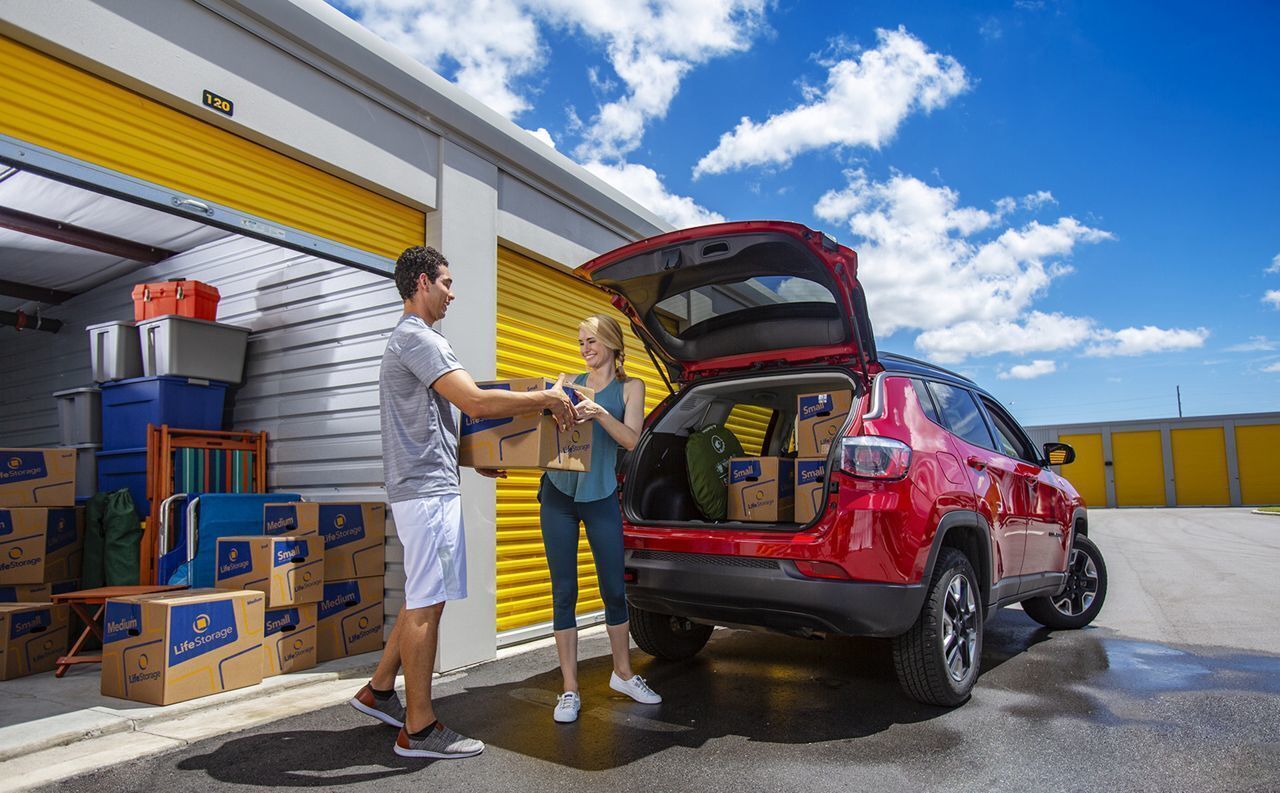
329 0 768 160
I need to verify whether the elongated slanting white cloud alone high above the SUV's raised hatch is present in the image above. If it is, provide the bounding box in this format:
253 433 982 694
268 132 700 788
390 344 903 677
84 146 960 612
694 27 969 177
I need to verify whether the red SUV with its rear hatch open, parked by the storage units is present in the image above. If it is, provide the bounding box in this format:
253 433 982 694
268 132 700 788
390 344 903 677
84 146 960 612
577 221 1106 706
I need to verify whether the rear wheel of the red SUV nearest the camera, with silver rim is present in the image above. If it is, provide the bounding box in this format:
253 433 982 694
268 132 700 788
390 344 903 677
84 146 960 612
893 547 983 707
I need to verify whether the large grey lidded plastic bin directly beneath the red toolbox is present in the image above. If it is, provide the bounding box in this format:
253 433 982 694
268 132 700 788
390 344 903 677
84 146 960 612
138 316 250 382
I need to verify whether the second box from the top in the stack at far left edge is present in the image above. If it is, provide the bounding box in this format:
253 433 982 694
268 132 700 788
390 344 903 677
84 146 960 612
0 506 84 586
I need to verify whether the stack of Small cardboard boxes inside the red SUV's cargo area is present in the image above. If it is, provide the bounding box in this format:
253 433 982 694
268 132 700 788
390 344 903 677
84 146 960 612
728 390 854 523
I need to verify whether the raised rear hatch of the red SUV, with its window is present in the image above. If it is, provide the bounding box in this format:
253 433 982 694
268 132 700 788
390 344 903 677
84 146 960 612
576 221 876 382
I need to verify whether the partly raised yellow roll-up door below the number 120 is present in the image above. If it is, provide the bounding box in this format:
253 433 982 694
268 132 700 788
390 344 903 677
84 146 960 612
0 36 425 258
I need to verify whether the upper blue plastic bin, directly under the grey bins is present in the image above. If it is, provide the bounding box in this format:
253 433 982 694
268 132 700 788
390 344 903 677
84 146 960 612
102 377 227 451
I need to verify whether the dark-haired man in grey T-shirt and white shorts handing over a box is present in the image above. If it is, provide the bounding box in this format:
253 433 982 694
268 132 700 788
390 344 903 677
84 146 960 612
351 246 576 758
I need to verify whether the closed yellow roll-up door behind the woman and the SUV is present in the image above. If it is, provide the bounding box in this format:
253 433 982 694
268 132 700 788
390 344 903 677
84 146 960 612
498 248 769 633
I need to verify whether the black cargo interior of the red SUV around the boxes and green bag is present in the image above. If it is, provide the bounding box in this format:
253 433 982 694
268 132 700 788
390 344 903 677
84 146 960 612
622 368 860 531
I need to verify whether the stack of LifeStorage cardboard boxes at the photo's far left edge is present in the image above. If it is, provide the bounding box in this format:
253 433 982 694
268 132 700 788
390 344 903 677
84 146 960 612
0 449 84 680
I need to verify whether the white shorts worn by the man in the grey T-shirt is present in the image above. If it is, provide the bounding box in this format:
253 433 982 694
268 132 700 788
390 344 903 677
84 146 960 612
392 495 467 609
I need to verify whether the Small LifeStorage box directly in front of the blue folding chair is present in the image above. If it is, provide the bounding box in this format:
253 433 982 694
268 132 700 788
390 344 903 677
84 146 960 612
214 535 324 609
